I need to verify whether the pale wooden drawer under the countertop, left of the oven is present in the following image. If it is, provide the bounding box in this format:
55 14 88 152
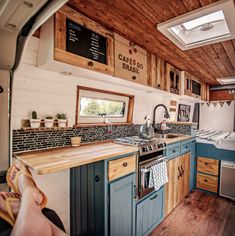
108 155 136 181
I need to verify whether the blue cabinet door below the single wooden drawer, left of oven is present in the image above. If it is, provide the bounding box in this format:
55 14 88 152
109 174 135 236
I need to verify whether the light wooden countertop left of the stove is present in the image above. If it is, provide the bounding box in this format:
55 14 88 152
14 142 138 175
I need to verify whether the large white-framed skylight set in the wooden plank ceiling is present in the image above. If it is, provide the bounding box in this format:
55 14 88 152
157 0 235 50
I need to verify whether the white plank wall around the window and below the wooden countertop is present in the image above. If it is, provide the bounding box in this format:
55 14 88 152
12 37 196 233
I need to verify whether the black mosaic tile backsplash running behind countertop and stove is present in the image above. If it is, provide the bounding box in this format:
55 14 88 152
13 124 194 152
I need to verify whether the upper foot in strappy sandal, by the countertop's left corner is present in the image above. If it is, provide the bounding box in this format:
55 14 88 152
10 164 43 204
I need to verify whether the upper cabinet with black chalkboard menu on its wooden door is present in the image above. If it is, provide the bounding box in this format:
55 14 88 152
39 6 114 75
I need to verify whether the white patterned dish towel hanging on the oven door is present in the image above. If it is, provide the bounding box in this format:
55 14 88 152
149 161 168 191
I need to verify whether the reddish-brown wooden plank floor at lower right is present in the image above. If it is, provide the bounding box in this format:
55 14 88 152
150 191 235 236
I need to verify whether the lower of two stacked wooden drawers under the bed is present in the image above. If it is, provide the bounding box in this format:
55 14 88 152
197 173 218 193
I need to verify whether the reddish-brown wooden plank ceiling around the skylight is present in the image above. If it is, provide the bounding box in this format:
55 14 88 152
68 0 235 85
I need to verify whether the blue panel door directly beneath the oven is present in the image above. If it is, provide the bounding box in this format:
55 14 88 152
136 188 164 236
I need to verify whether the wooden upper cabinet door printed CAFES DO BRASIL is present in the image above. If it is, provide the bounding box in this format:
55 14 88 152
114 34 149 85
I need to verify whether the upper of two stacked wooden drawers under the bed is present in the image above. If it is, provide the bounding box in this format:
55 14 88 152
197 157 219 176
